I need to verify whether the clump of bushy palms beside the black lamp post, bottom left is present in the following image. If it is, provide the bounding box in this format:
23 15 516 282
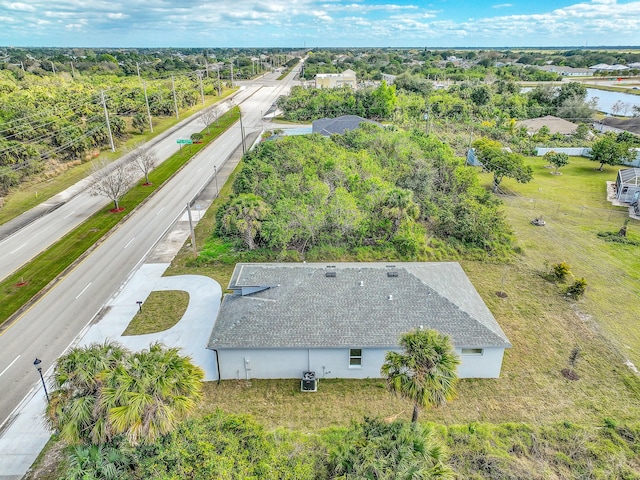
47 342 204 445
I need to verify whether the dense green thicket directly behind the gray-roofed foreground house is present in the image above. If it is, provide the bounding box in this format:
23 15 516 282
212 125 512 260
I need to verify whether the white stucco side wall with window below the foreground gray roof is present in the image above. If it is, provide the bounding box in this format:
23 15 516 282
218 346 504 380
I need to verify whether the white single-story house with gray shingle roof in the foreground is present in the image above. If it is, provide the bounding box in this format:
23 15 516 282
207 262 511 379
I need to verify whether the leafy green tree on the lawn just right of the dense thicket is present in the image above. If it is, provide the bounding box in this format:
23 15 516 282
473 138 533 192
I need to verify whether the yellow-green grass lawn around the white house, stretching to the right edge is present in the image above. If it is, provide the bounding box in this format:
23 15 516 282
169 147 640 431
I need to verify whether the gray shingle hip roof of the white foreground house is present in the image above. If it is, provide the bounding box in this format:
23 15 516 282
208 262 511 349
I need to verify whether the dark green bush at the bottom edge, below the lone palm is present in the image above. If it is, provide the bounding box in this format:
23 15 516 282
328 418 454 480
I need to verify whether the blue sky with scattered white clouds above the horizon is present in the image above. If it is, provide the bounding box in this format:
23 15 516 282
0 0 640 48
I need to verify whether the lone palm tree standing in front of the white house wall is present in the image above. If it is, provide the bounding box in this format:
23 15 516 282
381 330 460 423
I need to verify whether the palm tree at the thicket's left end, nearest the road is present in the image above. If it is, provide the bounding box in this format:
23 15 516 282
222 193 269 250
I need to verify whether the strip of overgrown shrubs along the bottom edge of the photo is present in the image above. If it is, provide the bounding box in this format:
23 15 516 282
50 410 640 480
